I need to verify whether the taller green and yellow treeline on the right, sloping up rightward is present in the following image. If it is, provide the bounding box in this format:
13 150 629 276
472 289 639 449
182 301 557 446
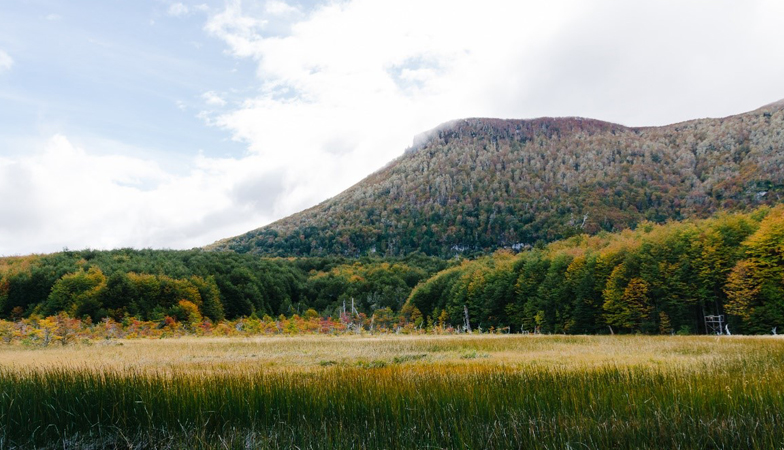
408 206 784 334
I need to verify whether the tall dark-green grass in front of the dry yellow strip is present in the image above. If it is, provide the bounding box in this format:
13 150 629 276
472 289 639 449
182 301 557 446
0 338 784 449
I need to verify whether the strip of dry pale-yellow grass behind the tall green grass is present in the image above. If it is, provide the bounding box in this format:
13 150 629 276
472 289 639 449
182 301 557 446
0 335 784 373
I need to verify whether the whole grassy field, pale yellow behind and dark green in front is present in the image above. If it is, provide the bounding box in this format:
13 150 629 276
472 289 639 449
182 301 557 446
0 335 784 449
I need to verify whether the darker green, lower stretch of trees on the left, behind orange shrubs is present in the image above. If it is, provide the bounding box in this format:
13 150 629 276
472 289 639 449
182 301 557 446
0 249 448 322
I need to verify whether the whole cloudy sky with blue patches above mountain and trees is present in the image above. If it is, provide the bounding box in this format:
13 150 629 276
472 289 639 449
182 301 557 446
0 0 784 256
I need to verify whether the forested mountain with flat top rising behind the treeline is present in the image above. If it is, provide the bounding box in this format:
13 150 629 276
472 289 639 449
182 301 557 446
207 101 784 257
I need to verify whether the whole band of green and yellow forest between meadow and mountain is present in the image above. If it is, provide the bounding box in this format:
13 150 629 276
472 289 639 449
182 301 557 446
0 205 784 334
